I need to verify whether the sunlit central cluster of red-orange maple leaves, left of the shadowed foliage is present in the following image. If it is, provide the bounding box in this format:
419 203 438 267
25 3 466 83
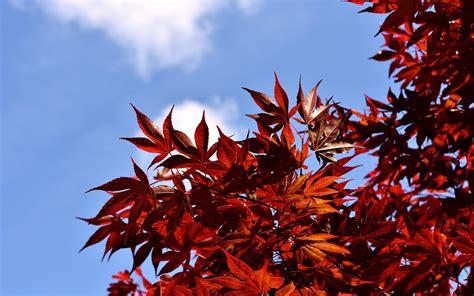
84 75 362 295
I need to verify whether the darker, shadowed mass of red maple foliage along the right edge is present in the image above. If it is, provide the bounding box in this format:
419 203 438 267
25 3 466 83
344 0 474 295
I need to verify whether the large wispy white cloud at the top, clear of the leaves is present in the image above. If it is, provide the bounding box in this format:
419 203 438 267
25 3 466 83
14 0 262 78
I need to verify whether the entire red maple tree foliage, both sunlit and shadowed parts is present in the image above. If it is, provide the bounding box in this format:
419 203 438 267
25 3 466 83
84 0 474 295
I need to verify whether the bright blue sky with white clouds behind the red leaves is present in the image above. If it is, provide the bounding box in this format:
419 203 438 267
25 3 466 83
0 0 390 295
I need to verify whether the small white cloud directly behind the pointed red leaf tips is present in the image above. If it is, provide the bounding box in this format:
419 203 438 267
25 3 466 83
135 97 246 168
